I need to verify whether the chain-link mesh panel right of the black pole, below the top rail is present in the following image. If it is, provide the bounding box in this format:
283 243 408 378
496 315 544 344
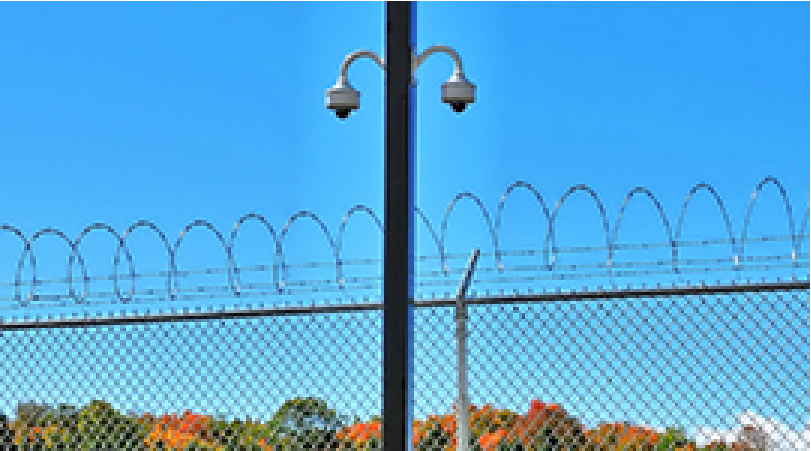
415 291 811 450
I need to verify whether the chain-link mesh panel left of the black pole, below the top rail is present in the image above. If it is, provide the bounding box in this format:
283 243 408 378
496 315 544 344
2 310 382 450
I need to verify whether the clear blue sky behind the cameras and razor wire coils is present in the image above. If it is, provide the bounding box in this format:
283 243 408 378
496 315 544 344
0 2 811 444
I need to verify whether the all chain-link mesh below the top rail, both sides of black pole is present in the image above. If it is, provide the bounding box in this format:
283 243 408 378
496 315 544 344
0 290 811 451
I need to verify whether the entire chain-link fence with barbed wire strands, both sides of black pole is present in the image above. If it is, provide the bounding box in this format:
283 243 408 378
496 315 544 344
0 183 811 451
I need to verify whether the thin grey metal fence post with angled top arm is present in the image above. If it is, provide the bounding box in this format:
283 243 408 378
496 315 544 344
456 248 480 451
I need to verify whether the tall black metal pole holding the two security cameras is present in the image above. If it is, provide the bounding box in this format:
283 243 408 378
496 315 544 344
383 2 416 451
